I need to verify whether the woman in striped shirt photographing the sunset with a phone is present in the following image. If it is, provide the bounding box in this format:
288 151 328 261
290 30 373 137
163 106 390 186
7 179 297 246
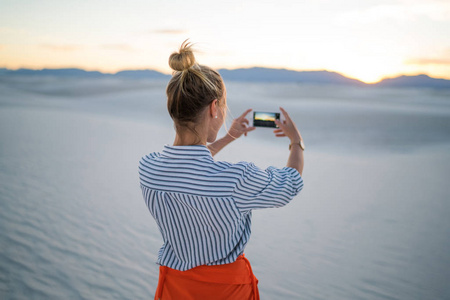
139 42 304 299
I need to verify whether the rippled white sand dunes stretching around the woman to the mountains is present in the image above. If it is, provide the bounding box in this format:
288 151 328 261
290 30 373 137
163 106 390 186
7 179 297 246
0 77 450 299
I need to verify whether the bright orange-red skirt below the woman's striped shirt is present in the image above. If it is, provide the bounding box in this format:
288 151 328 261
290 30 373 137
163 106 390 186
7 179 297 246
155 255 259 300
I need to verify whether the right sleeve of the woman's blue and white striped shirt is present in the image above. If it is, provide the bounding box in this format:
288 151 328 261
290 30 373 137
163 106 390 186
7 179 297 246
233 163 303 210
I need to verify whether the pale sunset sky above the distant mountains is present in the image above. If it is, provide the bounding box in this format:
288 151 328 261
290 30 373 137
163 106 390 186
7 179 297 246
0 0 450 82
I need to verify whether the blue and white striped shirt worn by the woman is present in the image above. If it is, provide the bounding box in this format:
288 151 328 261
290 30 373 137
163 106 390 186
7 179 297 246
139 145 303 271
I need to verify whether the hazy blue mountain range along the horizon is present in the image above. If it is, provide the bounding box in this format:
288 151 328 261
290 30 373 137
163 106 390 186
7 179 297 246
0 67 450 89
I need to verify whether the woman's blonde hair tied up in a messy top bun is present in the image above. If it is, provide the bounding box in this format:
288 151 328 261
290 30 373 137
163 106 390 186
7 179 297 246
166 40 224 131
